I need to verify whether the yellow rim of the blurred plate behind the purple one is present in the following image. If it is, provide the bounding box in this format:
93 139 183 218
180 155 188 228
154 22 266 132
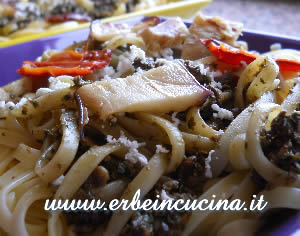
0 0 212 48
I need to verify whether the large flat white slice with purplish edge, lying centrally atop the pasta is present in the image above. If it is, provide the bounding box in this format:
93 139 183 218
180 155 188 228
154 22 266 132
78 61 211 119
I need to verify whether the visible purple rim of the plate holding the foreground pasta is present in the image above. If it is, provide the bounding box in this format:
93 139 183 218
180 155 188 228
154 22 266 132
0 17 300 236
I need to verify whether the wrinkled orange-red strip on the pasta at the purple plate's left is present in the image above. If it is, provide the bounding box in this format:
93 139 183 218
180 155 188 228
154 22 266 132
17 50 111 78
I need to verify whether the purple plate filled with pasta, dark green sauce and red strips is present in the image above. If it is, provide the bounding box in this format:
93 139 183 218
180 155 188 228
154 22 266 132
0 13 300 236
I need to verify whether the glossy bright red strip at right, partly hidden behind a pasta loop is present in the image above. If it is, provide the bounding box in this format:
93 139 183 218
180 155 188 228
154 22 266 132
200 39 300 72
